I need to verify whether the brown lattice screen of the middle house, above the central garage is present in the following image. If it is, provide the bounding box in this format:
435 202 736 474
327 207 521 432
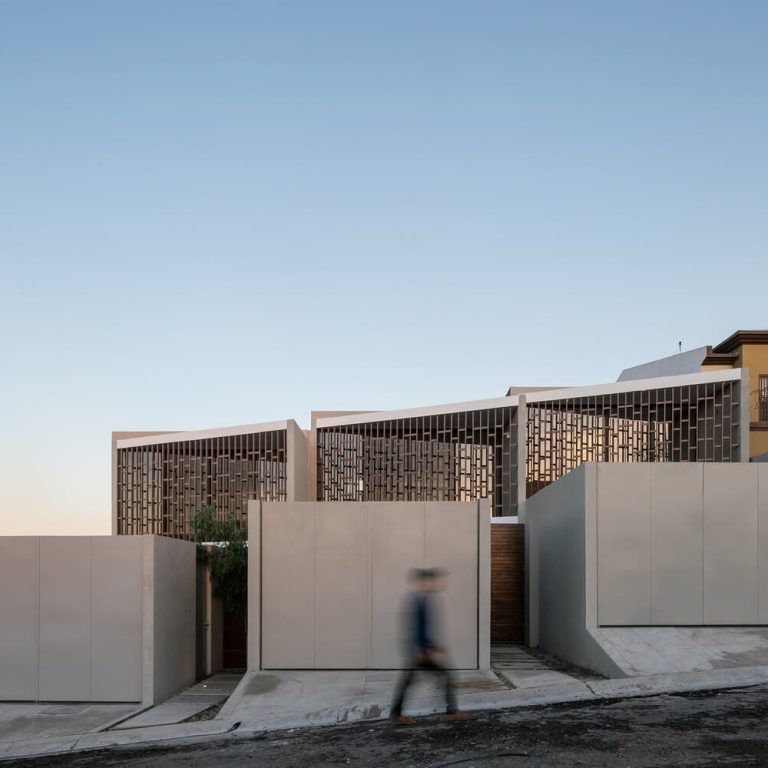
317 406 518 515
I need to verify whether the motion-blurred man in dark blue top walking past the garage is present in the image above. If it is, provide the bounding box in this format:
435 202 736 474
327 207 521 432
390 568 467 725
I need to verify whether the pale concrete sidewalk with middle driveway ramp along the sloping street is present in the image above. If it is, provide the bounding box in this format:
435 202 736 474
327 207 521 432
0 649 768 761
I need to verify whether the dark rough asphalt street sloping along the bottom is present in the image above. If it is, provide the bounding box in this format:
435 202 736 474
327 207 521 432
3 686 768 768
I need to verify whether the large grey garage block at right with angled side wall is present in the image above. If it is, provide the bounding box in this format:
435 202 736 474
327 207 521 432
526 463 768 674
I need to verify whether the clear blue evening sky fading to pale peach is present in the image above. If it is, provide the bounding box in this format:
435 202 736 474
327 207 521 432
0 0 768 535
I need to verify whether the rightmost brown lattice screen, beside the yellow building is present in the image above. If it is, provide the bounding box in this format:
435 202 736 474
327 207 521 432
526 381 741 496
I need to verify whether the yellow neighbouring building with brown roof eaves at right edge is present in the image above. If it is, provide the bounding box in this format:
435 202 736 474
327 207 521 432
701 331 768 457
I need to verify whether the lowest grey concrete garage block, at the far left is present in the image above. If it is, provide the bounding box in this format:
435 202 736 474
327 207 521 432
0 536 195 703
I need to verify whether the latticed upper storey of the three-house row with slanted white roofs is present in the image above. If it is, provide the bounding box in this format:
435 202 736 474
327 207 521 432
112 368 748 538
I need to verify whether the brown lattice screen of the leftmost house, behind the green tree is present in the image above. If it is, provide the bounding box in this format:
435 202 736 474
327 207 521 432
117 430 288 539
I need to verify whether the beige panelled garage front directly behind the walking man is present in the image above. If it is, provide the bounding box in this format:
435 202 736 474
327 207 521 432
248 502 490 669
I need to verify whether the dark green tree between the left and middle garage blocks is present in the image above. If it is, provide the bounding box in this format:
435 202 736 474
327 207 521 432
191 507 248 621
